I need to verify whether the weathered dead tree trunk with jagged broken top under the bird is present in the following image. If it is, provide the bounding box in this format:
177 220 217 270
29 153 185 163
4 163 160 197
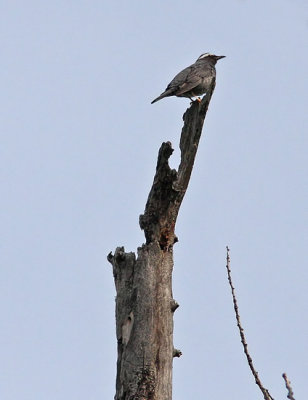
108 79 215 400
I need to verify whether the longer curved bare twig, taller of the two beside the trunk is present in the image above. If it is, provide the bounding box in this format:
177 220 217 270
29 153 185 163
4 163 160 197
226 246 274 400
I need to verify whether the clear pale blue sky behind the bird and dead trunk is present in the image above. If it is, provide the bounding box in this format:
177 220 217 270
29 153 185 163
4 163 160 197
0 0 308 400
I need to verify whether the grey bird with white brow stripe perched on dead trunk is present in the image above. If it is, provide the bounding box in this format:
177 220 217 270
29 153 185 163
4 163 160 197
151 53 225 104
